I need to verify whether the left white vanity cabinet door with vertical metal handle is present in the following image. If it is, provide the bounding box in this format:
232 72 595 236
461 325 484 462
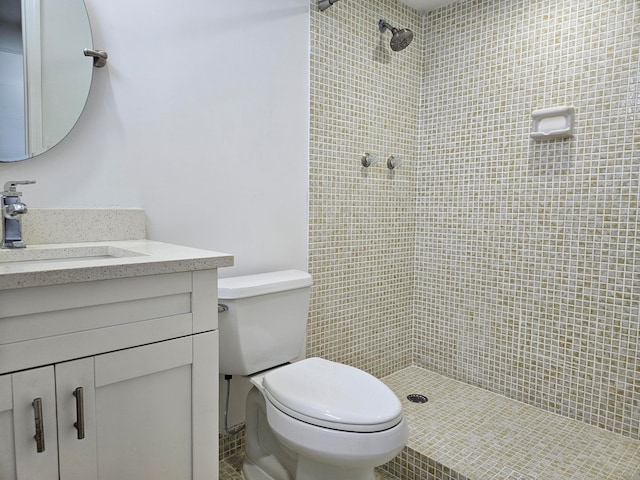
0 367 58 480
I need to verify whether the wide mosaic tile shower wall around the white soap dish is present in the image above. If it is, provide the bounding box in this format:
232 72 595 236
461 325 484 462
413 0 640 438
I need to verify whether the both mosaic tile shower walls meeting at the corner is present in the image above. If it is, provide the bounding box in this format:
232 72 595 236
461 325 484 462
307 0 640 446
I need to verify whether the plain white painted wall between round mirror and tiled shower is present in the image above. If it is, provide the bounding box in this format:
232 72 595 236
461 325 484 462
0 0 309 276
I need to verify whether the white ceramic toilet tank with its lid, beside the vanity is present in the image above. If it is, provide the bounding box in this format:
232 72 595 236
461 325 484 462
218 270 312 375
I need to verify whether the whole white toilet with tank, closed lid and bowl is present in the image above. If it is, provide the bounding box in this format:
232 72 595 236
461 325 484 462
218 270 408 480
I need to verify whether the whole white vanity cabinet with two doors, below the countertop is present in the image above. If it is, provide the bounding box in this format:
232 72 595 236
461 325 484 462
0 270 218 480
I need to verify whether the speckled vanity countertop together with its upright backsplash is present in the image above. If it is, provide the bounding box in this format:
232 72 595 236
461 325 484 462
0 208 233 290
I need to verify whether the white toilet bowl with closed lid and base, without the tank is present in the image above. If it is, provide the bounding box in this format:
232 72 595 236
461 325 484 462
244 358 408 480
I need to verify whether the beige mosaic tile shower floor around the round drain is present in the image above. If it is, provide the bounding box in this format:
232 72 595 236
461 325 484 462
382 367 640 480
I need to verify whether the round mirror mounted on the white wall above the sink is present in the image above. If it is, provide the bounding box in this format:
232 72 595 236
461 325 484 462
0 0 93 162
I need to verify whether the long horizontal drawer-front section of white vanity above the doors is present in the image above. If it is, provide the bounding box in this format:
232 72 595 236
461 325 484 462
0 270 217 373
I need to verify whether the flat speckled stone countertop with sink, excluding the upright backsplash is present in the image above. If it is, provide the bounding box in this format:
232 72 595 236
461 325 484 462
0 240 233 290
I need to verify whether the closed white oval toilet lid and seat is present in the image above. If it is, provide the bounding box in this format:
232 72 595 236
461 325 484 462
262 358 402 432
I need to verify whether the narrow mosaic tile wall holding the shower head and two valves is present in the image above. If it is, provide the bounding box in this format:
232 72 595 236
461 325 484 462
307 0 422 377
